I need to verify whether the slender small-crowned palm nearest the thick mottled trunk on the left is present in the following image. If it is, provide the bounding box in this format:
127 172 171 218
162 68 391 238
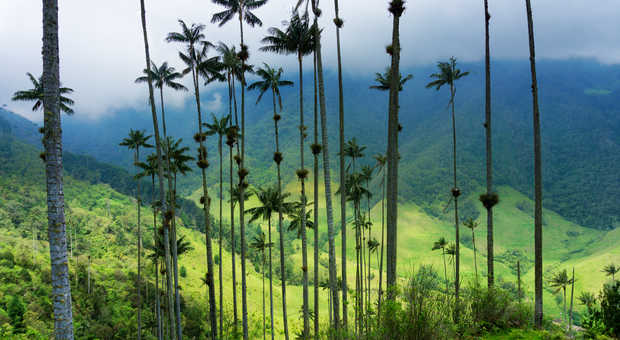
120 129 153 338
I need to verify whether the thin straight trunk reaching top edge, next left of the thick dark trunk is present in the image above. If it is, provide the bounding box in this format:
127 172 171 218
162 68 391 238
334 0 348 330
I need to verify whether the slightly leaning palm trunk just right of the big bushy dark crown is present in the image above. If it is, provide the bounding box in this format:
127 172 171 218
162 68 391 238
295 0 347 330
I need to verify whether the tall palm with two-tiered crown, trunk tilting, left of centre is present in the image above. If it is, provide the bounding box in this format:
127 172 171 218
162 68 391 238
166 20 220 339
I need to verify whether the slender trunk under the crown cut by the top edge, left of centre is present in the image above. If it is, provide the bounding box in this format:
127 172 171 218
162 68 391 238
239 11 256 340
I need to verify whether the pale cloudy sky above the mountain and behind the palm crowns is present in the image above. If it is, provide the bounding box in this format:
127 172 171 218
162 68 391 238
0 0 620 121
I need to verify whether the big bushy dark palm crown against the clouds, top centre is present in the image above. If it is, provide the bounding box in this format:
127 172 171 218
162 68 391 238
260 12 314 57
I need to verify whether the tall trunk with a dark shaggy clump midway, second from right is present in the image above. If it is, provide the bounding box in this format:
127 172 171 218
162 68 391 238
476 0 495 288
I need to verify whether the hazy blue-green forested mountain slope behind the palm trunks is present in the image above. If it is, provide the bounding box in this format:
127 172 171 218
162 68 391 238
2 60 620 230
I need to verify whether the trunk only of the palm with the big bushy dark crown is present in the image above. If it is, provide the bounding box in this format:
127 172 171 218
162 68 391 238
297 53 310 336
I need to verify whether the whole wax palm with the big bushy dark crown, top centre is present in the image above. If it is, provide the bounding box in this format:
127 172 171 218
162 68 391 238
260 12 314 334
